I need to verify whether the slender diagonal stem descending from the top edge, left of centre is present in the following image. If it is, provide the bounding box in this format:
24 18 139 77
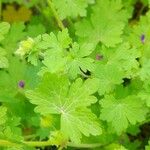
47 0 65 30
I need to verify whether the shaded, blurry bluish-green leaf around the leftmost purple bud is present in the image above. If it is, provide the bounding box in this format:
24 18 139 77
0 57 39 96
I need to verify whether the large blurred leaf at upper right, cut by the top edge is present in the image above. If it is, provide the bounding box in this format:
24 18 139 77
76 0 128 47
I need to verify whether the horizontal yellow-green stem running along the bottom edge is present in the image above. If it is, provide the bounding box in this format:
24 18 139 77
0 139 104 149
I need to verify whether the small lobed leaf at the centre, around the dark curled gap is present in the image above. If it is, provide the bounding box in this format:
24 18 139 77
67 43 95 79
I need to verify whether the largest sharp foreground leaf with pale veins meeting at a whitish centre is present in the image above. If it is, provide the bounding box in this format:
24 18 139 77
26 74 101 143
